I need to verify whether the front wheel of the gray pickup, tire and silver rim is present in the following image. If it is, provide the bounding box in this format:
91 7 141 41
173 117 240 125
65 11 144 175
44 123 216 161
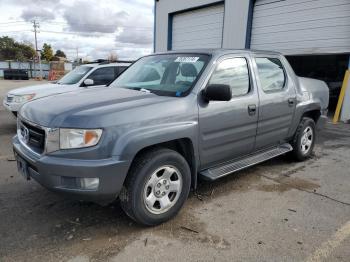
119 148 191 226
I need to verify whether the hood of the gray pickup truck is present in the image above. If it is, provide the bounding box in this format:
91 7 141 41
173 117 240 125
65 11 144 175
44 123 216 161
20 87 177 128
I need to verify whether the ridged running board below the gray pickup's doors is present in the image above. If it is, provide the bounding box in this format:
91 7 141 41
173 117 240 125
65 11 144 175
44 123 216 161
200 143 293 181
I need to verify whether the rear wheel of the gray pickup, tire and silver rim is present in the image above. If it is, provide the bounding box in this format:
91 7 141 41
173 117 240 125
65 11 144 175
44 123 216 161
291 117 316 161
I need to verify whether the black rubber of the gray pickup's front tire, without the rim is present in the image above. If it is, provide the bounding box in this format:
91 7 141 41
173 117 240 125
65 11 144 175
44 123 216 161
131 150 191 225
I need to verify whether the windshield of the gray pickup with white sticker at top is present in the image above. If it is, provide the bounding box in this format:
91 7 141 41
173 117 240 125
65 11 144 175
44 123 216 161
111 54 209 96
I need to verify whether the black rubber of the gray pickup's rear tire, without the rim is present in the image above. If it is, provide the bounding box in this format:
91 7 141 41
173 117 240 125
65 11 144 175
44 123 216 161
294 118 316 161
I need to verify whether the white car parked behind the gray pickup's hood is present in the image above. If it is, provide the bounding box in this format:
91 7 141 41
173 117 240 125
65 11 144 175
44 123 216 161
3 62 131 115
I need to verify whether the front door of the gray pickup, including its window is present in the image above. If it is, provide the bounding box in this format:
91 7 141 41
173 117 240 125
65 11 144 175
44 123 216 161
199 56 258 169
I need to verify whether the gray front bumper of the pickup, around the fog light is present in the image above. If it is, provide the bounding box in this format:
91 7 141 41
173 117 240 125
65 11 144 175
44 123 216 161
12 136 130 204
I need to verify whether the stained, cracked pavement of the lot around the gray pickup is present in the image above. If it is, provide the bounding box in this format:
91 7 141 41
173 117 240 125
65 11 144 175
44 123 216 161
0 81 350 262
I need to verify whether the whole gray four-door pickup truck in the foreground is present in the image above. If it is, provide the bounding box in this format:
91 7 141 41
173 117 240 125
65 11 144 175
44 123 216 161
13 50 329 225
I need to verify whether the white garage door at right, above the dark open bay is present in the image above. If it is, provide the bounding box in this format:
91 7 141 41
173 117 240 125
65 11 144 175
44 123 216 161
251 0 350 54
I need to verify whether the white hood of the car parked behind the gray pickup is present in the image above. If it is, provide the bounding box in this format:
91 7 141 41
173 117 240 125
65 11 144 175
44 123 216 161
9 83 77 99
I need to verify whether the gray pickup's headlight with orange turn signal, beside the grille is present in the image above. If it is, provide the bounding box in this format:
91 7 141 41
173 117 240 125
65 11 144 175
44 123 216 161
60 128 102 149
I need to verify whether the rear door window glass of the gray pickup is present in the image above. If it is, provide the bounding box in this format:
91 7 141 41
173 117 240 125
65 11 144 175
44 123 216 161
255 57 286 93
